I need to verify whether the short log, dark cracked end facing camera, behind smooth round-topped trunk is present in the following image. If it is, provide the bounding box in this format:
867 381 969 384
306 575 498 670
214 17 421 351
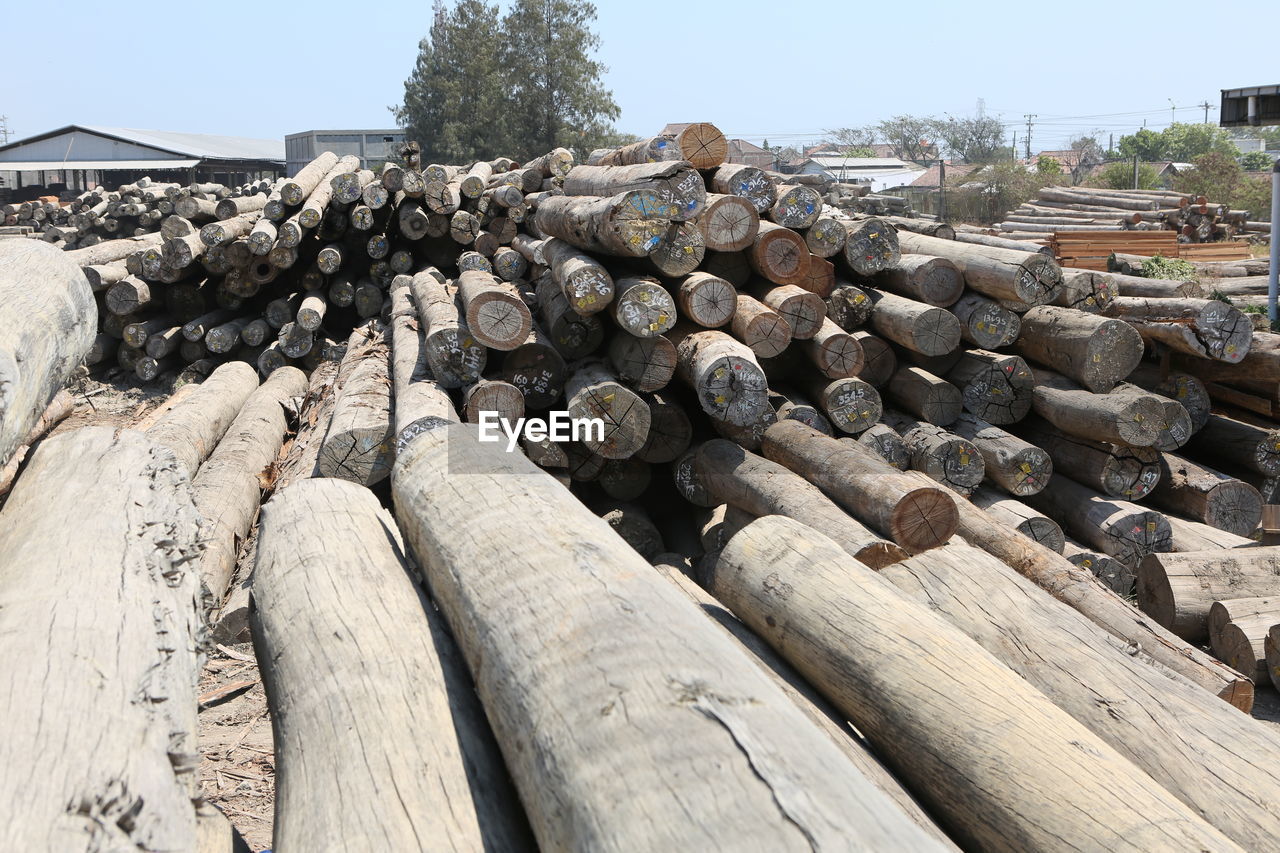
316 324 396 485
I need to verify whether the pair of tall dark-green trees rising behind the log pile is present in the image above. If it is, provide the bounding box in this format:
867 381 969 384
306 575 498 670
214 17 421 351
392 0 620 163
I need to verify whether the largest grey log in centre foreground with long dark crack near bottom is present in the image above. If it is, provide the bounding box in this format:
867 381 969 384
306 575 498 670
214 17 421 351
393 425 932 850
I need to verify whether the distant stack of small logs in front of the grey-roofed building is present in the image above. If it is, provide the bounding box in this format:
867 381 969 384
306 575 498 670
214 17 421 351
0 178 271 250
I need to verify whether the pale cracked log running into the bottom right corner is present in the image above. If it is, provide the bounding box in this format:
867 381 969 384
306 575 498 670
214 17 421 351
883 543 1280 849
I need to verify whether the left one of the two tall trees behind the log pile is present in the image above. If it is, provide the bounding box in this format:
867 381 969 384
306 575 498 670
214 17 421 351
392 0 511 163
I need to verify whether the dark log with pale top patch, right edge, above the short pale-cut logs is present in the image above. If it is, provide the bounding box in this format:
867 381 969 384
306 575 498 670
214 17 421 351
1151 453 1262 537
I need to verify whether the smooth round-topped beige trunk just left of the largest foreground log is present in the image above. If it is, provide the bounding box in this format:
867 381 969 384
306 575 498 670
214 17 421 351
252 479 532 850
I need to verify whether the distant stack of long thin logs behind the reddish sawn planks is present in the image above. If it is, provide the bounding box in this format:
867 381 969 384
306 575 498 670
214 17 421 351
998 187 1262 243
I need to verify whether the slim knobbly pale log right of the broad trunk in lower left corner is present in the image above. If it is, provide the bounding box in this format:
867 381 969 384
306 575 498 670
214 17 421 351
192 366 307 611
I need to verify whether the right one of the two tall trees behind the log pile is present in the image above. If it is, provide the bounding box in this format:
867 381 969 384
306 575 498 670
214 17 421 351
500 0 620 159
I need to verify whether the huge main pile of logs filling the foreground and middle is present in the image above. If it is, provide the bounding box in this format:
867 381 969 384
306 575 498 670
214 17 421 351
12 117 1280 850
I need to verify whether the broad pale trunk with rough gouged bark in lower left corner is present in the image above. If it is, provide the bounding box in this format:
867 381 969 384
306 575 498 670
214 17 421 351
0 427 201 852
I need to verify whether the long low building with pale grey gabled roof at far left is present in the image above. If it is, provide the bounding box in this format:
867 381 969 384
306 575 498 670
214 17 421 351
0 124 284 197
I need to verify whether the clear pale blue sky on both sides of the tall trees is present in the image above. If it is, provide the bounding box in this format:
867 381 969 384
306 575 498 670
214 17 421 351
0 0 1280 154
